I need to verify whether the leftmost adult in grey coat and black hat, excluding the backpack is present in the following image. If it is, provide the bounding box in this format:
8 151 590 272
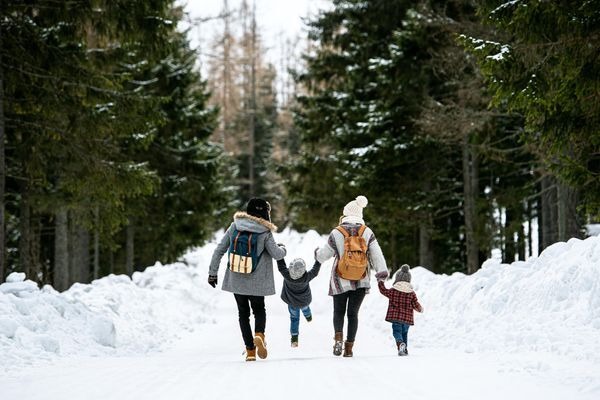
208 198 286 361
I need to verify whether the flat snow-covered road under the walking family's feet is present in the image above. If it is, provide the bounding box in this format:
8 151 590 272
0 291 593 400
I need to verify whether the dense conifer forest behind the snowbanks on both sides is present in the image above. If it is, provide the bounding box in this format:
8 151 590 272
0 0 600 290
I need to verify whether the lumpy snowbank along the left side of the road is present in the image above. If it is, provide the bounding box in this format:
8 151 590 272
0 263 211 371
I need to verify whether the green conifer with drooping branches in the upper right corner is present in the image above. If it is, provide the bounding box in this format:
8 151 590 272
467 1 600 222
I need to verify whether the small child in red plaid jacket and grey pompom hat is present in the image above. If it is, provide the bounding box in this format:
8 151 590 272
377 264 423 356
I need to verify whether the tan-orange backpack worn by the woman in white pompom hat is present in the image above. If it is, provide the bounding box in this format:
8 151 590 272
336 225 368 281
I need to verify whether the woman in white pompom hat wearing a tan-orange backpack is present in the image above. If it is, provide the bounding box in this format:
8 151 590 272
316 196 388 357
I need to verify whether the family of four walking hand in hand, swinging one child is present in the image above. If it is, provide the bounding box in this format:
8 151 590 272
208 196 422 361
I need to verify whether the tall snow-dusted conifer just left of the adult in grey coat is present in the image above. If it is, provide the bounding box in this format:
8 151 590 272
128 7 231 266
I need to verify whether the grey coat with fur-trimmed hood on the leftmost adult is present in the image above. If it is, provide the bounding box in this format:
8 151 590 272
209 211 286 296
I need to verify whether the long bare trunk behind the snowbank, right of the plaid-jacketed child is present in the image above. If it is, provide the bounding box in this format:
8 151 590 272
462 135 480 274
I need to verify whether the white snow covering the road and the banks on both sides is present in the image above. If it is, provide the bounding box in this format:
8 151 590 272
0 229 600 400
